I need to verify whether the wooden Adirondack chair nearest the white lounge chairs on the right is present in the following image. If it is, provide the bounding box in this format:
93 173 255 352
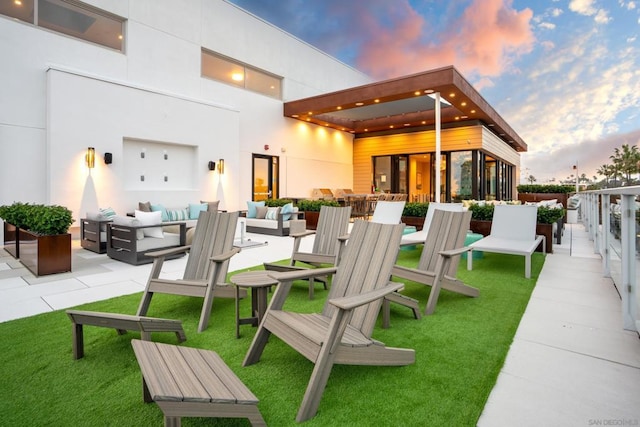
384 209 480 318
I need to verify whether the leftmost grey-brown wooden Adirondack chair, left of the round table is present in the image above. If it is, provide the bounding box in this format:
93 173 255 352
137 211 246 332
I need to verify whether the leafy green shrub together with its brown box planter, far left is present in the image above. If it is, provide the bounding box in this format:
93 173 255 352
0 203 73 276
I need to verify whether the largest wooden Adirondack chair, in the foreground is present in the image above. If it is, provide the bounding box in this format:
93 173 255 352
243 220 415 422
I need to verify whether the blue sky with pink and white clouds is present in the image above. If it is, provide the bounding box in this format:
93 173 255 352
230 0 640 182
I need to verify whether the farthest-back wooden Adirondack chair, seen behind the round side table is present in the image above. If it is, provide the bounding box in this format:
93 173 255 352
264 206 351 299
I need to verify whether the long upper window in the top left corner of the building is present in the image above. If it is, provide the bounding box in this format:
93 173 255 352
0 0 125 51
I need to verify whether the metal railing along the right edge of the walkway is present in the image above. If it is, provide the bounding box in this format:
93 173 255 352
578 186 640 332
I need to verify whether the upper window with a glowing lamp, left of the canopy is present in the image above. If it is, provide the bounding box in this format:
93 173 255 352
201 49 282 99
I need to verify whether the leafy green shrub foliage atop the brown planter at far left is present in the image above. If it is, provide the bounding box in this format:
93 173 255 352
0 202 73 236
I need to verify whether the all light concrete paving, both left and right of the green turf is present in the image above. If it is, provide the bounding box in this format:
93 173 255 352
0 224 640 427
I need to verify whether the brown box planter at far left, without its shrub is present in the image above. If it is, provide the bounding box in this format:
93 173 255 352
19 230 71 276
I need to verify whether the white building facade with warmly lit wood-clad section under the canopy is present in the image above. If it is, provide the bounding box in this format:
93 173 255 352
0 0 526 234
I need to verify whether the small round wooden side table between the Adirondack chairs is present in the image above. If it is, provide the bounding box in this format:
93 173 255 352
229 270 278 338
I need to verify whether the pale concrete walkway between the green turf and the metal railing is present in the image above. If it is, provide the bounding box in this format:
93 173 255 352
478 224 640 427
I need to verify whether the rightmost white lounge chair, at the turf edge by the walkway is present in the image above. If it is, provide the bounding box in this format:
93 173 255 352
467 205 546 279
